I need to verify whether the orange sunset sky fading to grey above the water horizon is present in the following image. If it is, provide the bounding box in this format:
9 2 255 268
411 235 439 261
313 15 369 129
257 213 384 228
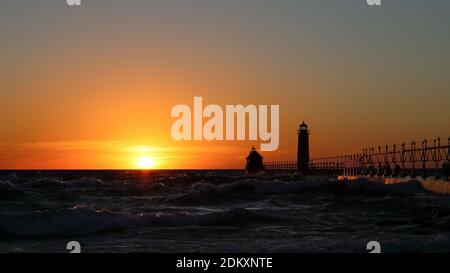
0 0 450 169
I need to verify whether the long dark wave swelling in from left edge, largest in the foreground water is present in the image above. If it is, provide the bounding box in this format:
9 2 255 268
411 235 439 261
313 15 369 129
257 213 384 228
0 207 287 237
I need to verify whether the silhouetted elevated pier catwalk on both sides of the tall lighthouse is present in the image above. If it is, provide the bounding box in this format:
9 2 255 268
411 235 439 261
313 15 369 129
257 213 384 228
265 137 450 178
